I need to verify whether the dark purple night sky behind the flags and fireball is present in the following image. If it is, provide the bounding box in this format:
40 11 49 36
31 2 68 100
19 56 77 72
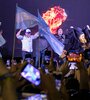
0 0 90 56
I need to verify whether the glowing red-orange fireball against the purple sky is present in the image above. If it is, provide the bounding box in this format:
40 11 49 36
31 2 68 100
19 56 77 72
42 6 67 34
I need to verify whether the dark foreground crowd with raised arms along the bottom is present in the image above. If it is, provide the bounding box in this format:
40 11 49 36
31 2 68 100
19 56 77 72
0 50 90 100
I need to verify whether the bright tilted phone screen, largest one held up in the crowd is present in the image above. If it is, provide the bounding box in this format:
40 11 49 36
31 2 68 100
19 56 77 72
21 64 40 85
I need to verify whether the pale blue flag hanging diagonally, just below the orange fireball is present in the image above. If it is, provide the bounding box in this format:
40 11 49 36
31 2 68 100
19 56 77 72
38 11 64 55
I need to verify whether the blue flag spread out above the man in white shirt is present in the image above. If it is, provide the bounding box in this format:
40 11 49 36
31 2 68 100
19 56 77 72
16 6 38 29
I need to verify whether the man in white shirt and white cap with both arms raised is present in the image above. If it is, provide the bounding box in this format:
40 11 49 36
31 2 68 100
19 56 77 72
16 29 39 60
